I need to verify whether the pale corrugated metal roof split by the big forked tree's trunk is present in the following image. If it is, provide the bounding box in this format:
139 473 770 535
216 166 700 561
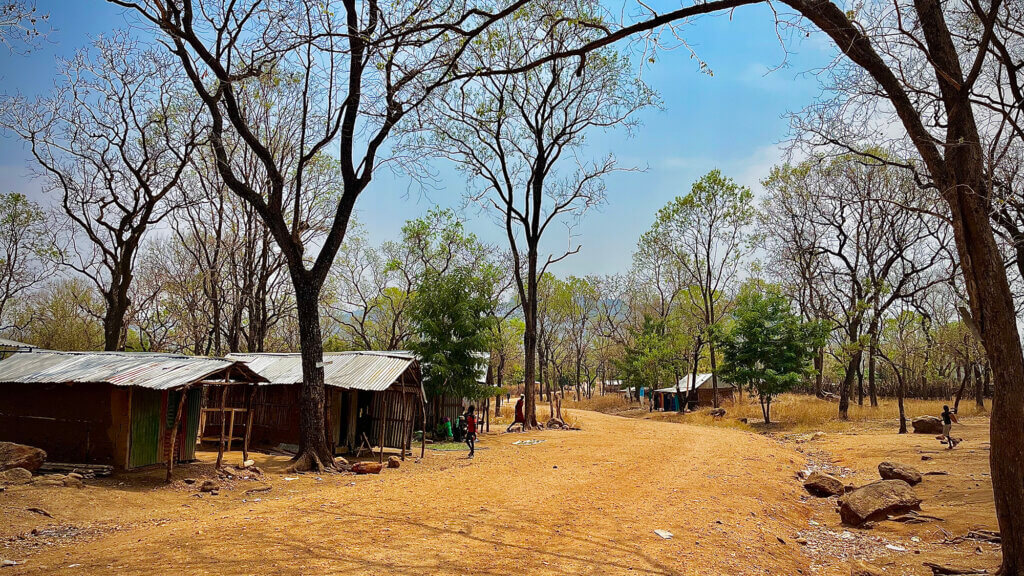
227 352 416 392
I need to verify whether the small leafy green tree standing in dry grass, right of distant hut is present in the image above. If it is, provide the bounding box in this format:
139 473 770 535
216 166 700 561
712 280 826 424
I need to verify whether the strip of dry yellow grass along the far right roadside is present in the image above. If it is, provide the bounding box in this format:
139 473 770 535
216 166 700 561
566 387 987 433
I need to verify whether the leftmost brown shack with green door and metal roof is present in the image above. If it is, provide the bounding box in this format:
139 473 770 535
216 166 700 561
0 352 260 470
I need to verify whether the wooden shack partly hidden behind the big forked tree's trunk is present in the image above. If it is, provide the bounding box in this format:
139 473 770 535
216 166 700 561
211 352 424 454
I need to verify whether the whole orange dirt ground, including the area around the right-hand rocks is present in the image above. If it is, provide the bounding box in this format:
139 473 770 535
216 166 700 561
0 411 998 576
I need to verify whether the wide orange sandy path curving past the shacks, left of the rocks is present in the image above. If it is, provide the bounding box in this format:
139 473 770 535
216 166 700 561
0 411 815 575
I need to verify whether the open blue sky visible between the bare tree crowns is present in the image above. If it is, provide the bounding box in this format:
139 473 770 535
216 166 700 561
0 0 835 275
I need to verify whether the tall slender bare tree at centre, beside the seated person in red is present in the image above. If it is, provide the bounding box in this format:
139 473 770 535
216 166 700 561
415 5 653 426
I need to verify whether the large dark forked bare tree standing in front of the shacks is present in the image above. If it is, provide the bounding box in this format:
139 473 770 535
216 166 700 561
110 0 544 468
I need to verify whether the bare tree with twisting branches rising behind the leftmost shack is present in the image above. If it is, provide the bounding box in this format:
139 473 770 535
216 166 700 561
2 34 200 351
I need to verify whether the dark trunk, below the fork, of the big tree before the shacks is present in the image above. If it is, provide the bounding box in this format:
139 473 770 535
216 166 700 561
293 279 334 471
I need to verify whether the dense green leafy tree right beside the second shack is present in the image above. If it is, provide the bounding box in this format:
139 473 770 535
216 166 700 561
410 266 495 398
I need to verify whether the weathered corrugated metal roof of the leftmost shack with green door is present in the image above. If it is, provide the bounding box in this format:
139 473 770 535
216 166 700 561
0 352 261 389
